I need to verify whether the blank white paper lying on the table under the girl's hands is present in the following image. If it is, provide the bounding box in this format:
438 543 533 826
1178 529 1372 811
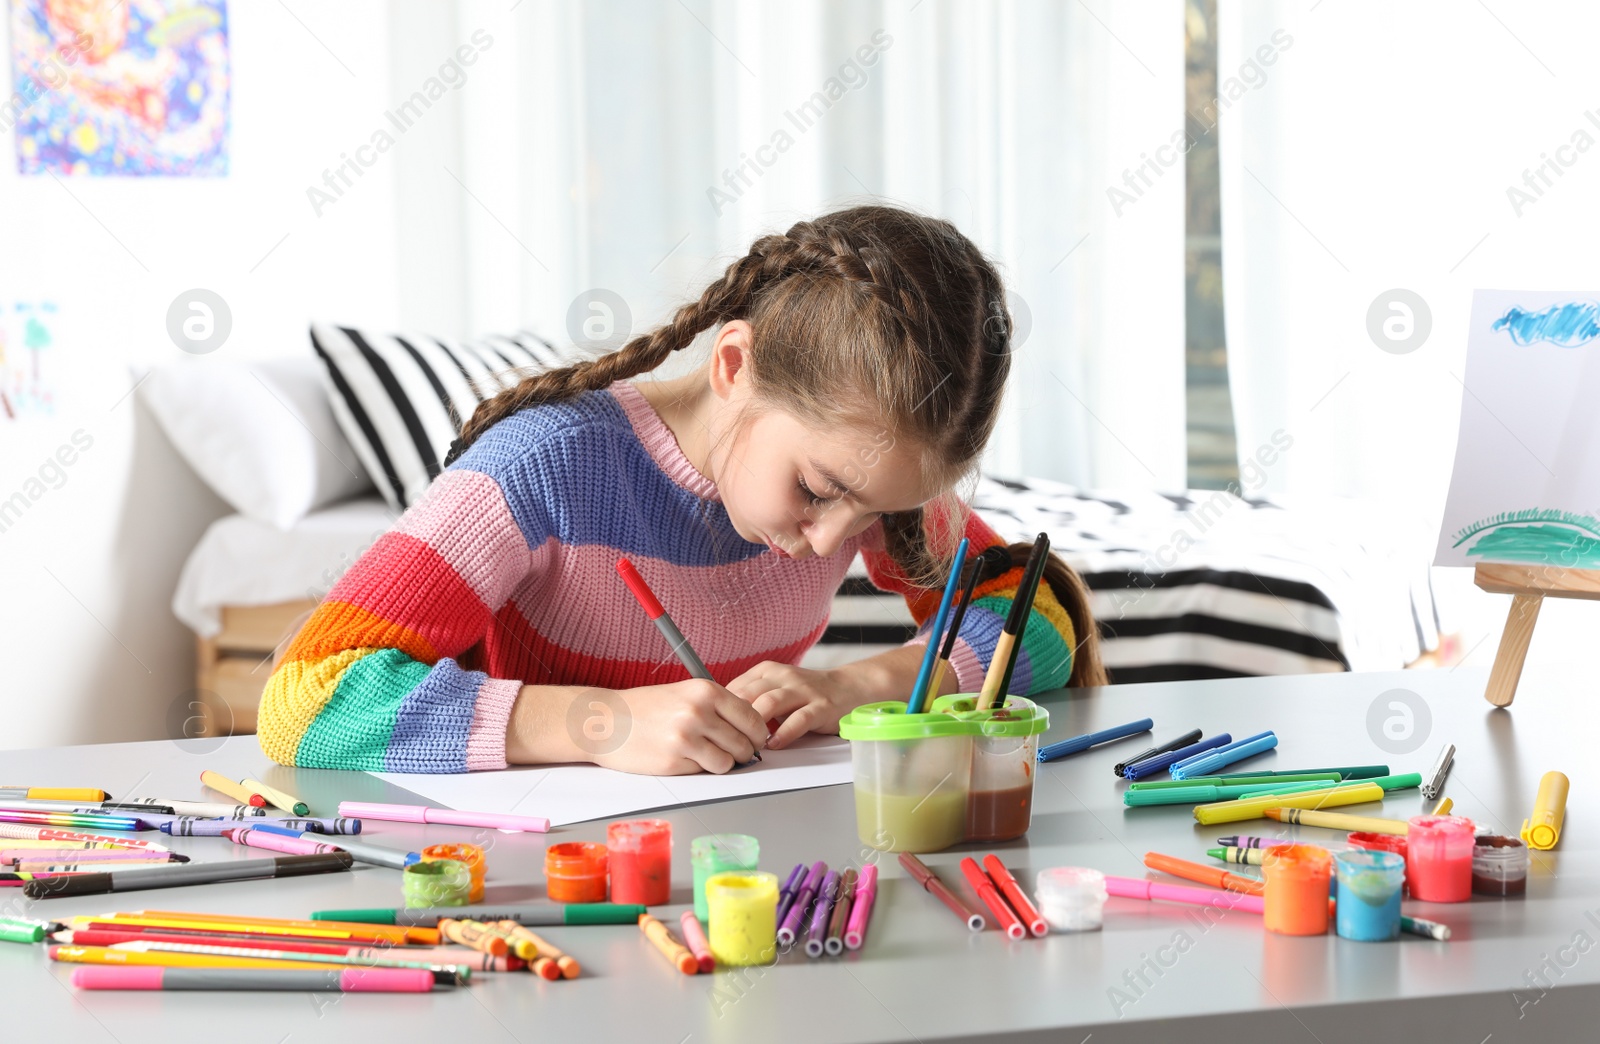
373 735 851 826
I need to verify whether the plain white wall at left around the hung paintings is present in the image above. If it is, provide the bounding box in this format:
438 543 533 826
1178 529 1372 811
0 0 416 748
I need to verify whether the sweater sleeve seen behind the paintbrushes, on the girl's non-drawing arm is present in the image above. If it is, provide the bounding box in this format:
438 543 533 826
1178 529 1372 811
861 511 1077 697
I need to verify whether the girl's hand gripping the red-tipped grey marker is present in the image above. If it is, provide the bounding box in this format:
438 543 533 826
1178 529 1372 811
592 677 766 775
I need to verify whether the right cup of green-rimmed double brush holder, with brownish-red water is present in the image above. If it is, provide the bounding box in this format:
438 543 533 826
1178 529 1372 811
928 695 1050 841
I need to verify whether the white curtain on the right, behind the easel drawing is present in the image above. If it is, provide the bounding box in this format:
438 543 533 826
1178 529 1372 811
1218 0 1600 522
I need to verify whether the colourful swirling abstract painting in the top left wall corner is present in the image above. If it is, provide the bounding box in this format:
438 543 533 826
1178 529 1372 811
0 0 229 176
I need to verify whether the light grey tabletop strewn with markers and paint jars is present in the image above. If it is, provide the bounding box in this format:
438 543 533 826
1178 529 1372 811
0 669 1600 1044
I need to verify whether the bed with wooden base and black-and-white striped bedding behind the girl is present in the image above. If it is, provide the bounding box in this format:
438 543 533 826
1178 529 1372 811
173 477 1440 735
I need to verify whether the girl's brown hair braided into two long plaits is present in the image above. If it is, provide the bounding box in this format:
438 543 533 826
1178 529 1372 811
445 205 1093 684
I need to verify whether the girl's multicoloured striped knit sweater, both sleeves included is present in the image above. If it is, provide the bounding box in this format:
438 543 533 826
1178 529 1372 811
258 381 1074 772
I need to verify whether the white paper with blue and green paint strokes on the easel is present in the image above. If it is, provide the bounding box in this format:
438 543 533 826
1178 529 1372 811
1434 290 1600 568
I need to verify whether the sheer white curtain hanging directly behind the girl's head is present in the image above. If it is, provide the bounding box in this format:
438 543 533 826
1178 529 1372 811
392 0 1184 487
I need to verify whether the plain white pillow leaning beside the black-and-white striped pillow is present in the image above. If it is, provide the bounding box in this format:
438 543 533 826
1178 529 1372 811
139 354 373 528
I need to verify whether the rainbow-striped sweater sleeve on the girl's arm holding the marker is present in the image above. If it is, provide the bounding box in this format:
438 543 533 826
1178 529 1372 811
258 431 544 772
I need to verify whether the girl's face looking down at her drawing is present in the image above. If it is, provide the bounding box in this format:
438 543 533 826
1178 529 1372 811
709 381 941 559
